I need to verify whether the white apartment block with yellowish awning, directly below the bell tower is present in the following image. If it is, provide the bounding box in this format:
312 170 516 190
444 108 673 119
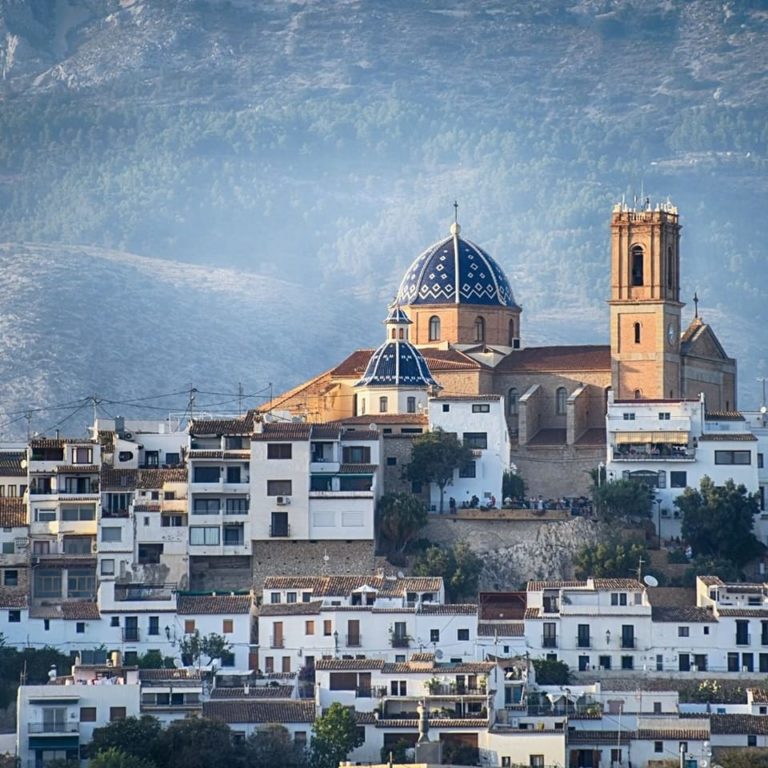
605 391 768 543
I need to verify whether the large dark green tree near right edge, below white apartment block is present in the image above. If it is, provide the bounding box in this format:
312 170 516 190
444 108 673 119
675 476 765 567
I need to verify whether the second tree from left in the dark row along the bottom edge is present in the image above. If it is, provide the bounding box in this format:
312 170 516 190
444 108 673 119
162 717 237 768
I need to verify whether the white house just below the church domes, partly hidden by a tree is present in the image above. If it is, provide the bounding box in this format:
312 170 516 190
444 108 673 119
428 395 510 512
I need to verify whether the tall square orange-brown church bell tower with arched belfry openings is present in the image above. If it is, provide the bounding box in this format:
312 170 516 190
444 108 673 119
608 200 684 400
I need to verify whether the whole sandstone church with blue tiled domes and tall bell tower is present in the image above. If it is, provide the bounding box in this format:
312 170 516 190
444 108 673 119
267 200 736 498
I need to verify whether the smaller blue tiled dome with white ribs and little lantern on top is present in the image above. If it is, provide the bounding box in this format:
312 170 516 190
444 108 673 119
355 304 440 387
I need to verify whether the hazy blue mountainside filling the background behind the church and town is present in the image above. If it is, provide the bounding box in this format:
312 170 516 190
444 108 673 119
0 0 768 432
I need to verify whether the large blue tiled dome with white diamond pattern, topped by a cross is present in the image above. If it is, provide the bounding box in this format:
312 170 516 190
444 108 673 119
397 230 517 307
